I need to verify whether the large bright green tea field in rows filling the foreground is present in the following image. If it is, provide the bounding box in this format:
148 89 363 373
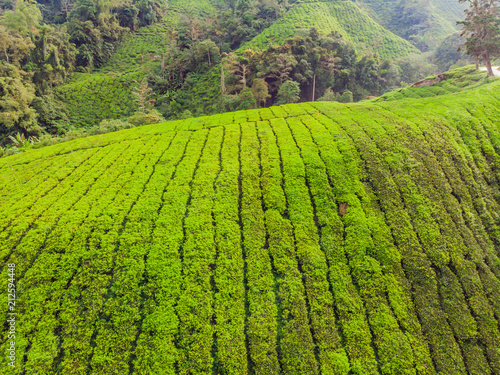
0 75 500 375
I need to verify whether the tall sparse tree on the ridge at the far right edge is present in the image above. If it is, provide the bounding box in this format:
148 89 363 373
457 0 500 77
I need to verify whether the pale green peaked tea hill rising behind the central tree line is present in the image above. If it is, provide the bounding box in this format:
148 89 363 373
241 1 419 59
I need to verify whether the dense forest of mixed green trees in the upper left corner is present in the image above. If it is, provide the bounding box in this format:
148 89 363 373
0 0 166 144
